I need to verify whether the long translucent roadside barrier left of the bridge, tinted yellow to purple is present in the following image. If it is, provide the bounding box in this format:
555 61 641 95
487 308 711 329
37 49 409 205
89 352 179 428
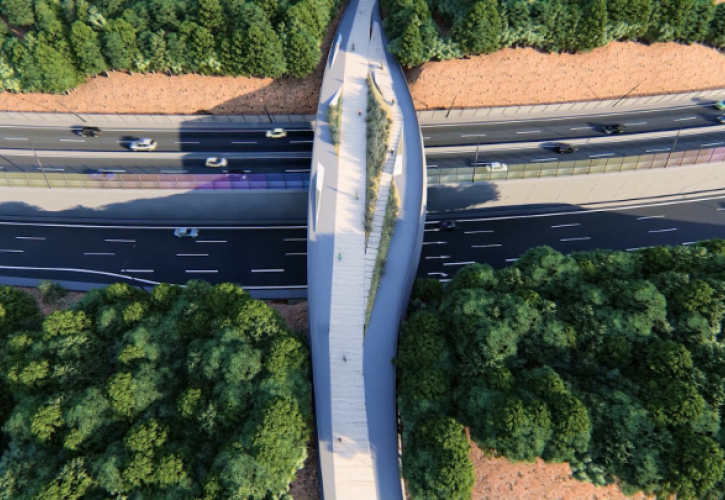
0 169 310 191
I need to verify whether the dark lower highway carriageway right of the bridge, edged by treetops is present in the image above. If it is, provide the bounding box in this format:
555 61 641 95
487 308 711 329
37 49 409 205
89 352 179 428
418 198 725 280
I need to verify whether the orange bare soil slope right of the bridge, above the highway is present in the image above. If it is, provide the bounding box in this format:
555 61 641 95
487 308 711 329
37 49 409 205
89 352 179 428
408 42 725 110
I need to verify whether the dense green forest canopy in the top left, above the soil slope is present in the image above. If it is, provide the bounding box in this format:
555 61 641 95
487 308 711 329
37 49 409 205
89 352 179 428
0 0 338 93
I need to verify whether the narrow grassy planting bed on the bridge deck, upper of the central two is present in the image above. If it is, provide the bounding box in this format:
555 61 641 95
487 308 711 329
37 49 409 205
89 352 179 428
365 75 393 240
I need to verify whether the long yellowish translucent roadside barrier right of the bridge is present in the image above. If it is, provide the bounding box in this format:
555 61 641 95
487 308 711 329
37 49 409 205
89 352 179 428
427 148 725 186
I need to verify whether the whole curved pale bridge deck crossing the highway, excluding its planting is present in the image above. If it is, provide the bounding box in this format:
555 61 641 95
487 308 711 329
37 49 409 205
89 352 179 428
308 0 425 500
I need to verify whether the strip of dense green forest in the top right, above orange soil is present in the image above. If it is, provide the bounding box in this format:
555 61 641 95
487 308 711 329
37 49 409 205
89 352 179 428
381 0 725 67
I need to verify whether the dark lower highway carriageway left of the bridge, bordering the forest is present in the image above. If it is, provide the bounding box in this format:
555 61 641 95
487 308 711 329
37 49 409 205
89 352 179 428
0 222 307 289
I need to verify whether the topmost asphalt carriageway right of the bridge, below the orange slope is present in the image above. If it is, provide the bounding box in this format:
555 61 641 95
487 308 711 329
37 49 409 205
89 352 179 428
421 103 724 147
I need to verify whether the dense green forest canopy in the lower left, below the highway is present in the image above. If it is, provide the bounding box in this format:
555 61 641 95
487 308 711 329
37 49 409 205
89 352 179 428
0 281 312 500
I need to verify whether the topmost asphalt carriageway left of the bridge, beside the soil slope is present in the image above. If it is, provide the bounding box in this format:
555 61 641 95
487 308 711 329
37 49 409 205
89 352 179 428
0 123 314 152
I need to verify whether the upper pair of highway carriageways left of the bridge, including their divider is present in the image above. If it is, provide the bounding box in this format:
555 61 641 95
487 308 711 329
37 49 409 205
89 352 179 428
0 123 313 174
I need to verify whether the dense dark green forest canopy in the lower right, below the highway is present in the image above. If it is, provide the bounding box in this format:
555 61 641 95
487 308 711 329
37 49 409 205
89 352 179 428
396 240 725 500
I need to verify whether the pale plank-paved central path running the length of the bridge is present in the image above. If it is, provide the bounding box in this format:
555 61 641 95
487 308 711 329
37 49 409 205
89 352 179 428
329 0 379 500
